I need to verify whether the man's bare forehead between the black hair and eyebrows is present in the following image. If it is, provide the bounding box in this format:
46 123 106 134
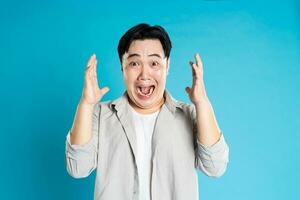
126 39 164 57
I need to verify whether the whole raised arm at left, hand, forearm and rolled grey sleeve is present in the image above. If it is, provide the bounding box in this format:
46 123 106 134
66 55 108 178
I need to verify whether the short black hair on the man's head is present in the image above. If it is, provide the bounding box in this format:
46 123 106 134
118 23 172 63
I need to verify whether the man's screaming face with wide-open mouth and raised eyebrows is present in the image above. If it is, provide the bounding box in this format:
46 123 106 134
122 39 169 109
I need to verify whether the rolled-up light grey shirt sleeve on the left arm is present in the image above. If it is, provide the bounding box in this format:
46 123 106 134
65 104 100 178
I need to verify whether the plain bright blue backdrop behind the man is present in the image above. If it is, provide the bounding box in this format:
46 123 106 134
0 0 300 200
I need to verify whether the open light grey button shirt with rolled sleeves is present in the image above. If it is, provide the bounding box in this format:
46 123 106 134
66 90 229 200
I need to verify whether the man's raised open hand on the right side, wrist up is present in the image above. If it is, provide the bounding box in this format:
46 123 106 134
185 53 207 105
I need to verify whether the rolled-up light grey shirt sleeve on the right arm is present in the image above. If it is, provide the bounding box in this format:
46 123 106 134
191 104 229 177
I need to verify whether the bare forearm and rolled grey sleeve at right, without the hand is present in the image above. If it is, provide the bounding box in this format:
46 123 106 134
192 102 229 177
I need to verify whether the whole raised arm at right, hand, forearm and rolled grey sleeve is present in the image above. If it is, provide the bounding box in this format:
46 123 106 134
186 54 229 177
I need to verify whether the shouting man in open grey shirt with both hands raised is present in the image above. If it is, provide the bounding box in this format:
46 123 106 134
66 24 229 200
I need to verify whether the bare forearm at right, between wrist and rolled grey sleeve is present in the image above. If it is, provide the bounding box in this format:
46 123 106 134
194 97 220 146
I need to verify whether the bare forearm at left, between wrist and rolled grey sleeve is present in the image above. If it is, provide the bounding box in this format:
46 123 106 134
70 101 94 145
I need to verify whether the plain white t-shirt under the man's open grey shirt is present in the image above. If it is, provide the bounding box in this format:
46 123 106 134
130 106 159 200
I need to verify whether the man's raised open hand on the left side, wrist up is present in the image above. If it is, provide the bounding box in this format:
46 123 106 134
80 54 109 105
